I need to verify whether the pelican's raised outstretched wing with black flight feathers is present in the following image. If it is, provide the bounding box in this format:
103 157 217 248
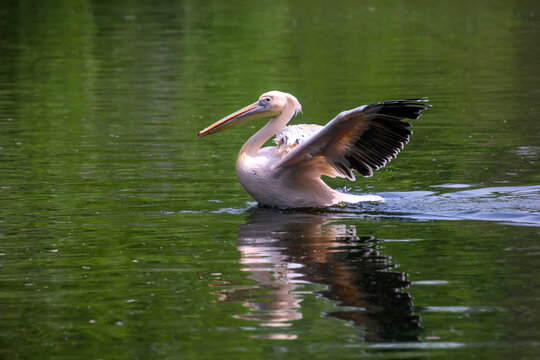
275 98 430 180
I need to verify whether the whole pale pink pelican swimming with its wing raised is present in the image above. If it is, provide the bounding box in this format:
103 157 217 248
198 91 429 208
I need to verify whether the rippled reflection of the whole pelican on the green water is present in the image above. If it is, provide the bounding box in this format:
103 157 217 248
215 208 420 341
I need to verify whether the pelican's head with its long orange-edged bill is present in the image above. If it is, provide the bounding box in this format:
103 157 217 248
198 91 302 138
